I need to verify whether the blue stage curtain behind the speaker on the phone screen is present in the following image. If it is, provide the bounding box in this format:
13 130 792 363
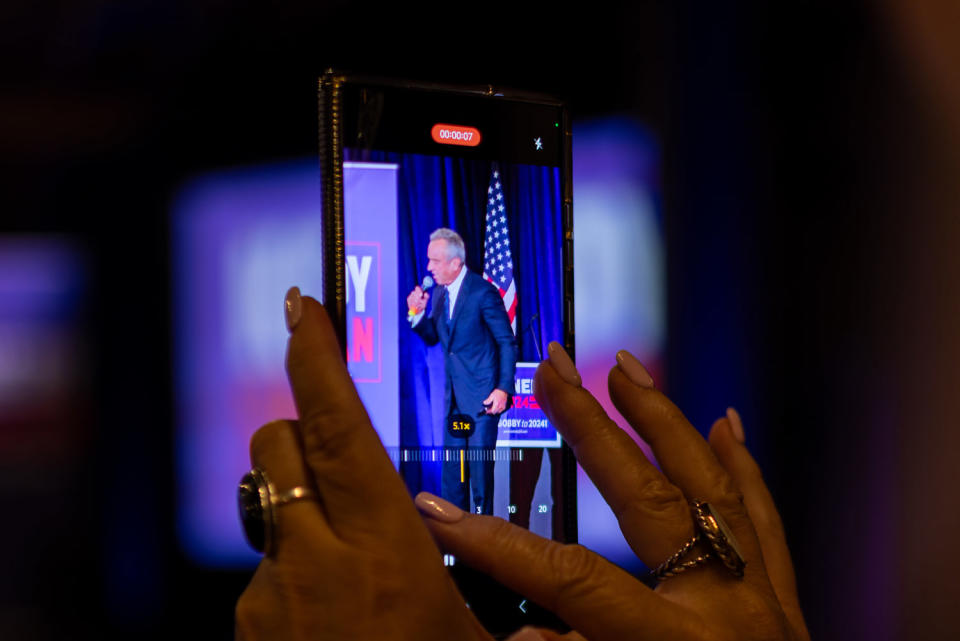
347 150 563 494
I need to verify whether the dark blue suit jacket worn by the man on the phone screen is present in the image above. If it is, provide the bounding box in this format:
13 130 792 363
413 271 517 424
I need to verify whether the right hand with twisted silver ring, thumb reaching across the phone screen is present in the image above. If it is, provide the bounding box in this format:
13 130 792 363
416 343 809 641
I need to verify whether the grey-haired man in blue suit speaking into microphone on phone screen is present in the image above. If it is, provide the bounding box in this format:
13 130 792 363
407 228 517 514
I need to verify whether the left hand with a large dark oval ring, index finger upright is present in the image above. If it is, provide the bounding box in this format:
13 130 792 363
236 289 490 641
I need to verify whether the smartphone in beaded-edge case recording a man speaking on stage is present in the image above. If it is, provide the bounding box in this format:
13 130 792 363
319 71 577 636
